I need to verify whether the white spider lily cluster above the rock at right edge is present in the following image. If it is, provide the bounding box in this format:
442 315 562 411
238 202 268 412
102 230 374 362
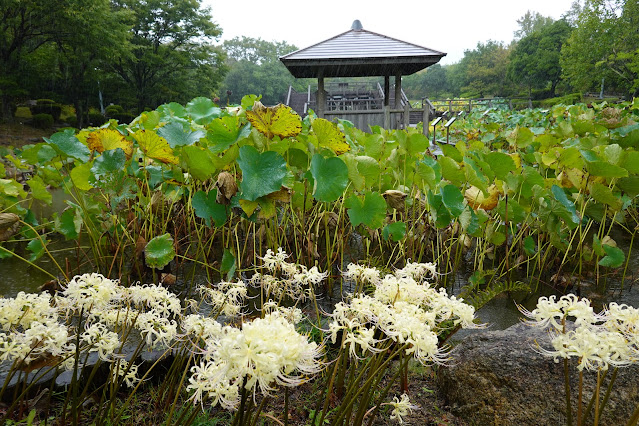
519 294 639 371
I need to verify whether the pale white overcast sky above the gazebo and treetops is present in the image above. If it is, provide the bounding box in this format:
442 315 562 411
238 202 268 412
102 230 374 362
202 0 573 64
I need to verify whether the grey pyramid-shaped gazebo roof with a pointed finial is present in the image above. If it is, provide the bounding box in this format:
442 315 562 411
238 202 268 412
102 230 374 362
280 20 446 78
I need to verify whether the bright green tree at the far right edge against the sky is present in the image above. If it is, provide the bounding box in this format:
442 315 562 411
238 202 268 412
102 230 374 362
561 0 639 96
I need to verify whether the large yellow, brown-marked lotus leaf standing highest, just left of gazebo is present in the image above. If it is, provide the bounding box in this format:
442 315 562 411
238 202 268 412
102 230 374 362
246 101 302 139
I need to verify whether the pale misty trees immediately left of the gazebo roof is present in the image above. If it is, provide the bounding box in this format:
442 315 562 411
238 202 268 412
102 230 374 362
221 37 305 105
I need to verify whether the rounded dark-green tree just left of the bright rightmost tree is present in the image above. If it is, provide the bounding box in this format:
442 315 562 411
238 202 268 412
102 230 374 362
508 20 572 97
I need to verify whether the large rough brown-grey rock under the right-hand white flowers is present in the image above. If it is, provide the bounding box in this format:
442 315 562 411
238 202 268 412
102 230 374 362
438 324 639 426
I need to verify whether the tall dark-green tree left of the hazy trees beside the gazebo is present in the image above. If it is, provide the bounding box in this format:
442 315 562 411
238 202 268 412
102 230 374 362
112 0 223 111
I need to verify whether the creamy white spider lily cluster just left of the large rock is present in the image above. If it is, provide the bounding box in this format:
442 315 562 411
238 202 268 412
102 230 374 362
329 263 479 363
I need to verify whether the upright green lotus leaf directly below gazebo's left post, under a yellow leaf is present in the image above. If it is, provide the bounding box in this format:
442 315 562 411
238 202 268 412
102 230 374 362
310 154 348 203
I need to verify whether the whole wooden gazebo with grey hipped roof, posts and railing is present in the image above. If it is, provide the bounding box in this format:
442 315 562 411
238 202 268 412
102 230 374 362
280 20 446 130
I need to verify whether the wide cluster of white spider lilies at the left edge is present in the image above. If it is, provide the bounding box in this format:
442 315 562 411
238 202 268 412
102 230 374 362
0 273 182 384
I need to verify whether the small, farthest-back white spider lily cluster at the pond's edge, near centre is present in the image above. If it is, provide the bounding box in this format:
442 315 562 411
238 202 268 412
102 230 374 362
250 247 328 302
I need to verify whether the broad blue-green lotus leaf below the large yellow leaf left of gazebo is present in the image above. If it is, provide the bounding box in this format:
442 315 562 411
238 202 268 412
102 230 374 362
237 145 287 201
